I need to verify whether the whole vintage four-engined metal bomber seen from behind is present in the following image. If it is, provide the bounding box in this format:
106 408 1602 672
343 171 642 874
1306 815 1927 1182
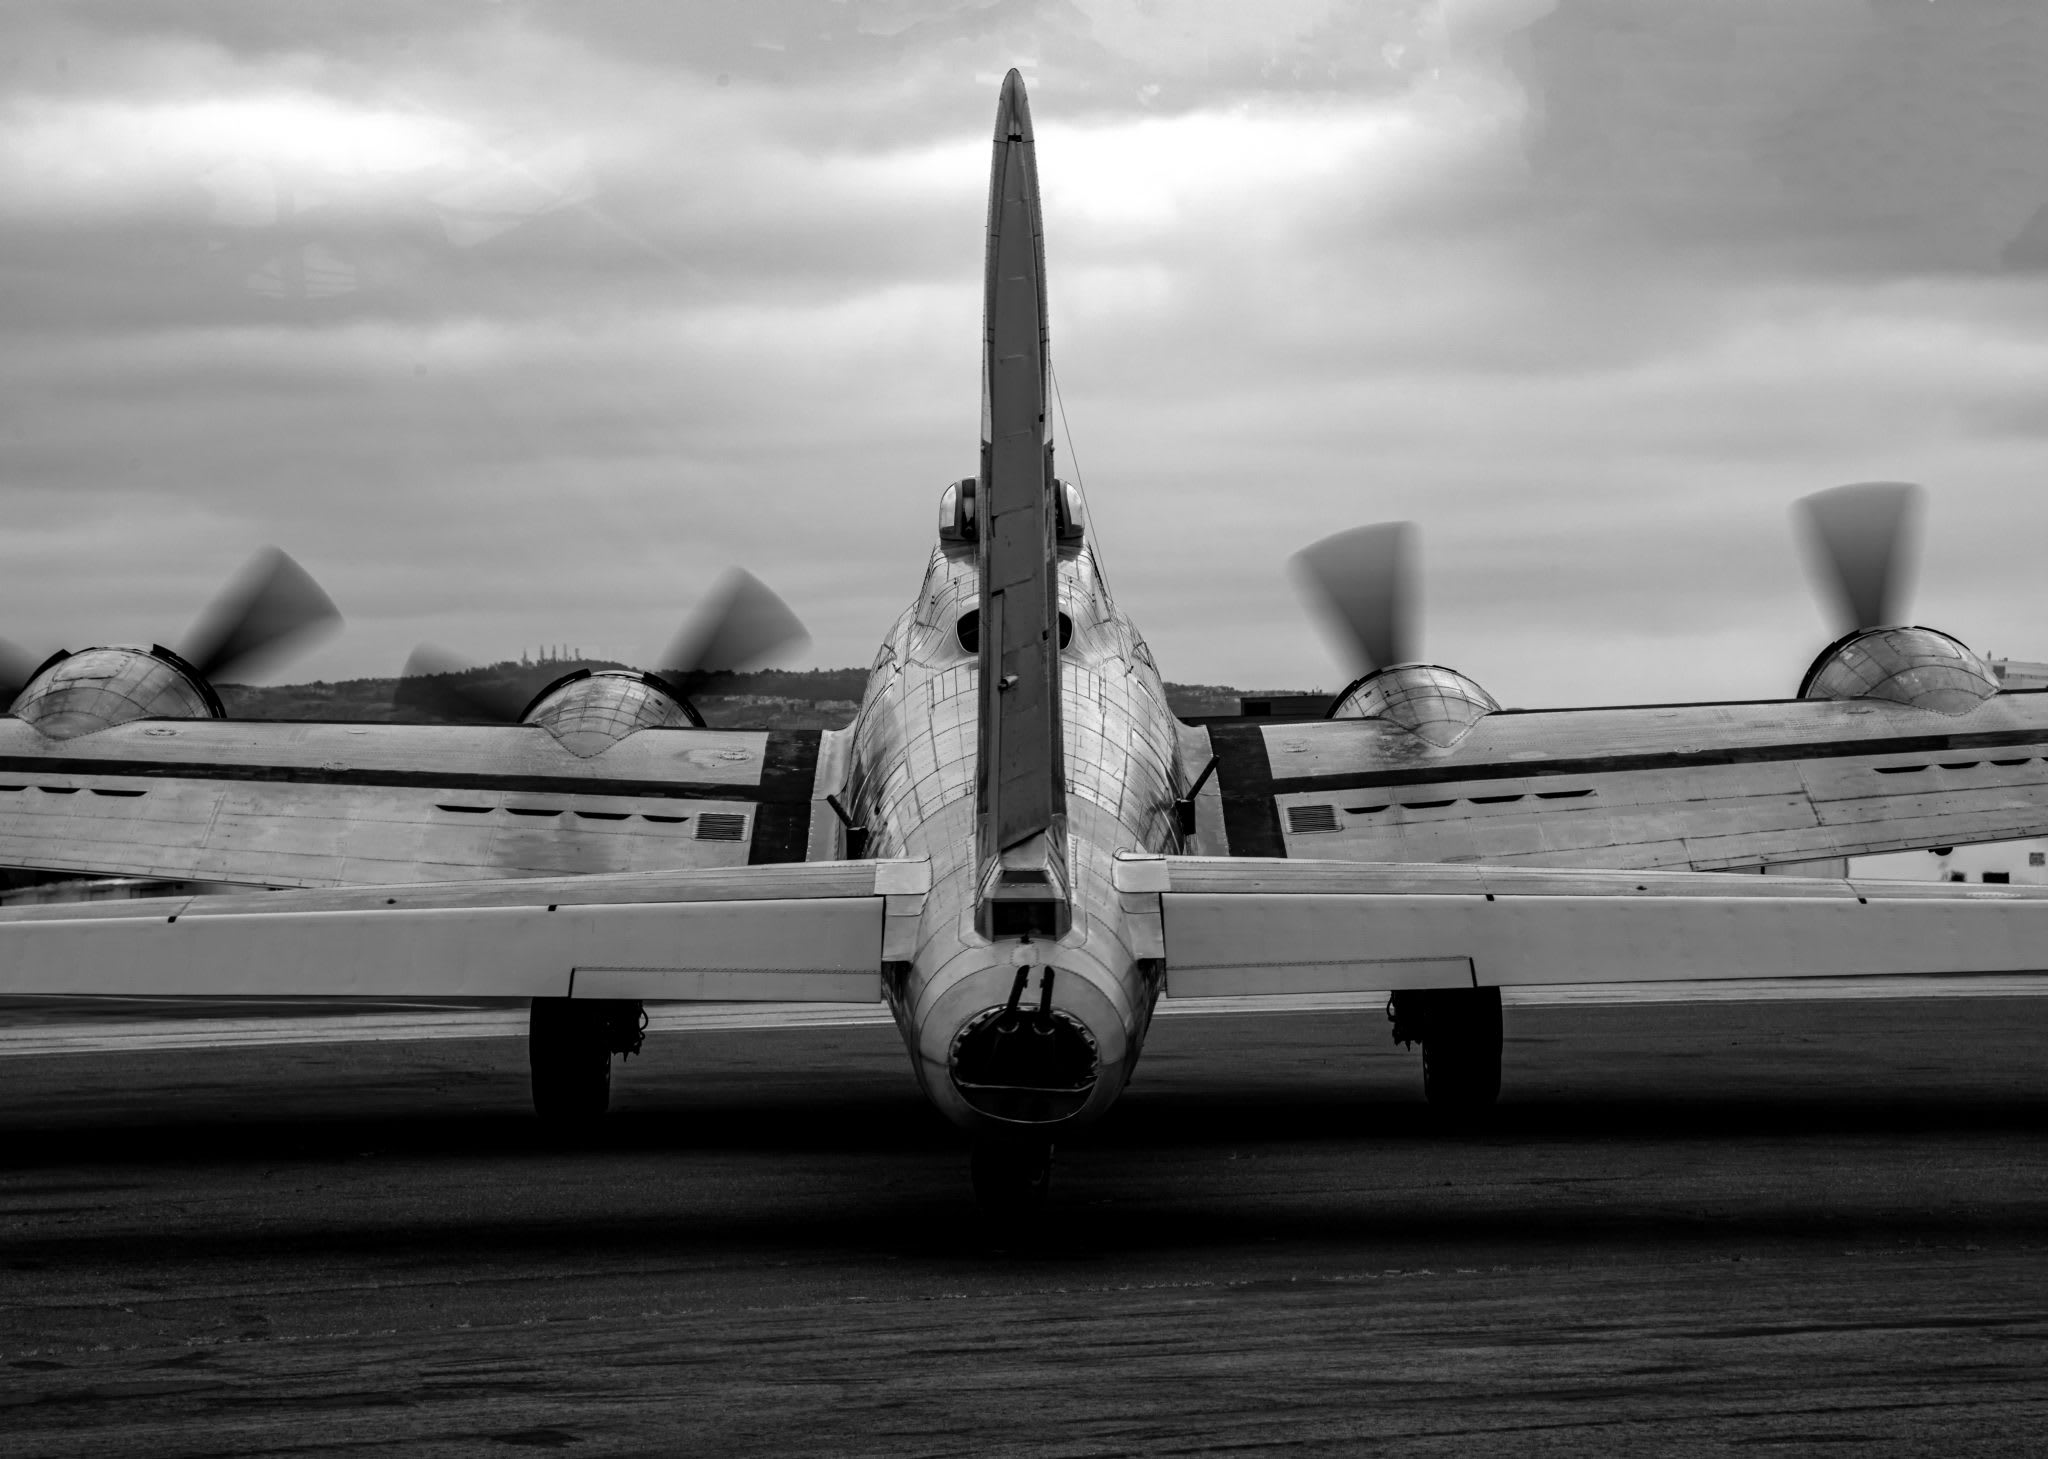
0 72 2048 1207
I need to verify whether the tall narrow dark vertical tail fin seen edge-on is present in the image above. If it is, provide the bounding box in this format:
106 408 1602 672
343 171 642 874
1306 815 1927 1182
975 72 1067 934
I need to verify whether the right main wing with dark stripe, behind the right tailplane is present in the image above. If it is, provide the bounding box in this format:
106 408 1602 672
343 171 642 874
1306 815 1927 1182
1184 693 2048 871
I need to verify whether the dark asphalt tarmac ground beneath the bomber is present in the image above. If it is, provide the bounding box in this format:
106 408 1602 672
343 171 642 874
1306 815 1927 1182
0 998 2048 1459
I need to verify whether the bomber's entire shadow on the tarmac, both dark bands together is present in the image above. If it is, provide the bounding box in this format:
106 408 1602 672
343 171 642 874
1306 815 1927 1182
0 1088 2048 1270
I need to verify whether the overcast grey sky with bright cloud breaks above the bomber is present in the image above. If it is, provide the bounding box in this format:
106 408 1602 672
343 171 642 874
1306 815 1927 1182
0 0 2048 705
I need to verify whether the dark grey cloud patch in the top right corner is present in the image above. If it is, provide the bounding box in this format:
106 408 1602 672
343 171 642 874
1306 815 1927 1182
1511 0 2048 270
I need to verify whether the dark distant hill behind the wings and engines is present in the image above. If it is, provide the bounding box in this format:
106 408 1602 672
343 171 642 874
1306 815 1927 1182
219 660 1286 730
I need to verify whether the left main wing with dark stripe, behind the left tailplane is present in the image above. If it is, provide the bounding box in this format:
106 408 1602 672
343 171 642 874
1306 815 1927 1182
0 719 840 887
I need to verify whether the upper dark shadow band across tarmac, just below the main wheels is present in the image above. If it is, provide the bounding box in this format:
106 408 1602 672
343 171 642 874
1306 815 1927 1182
12 1086 2048 1170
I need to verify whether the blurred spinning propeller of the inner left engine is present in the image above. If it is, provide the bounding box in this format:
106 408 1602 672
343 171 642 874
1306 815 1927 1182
393 568 811 723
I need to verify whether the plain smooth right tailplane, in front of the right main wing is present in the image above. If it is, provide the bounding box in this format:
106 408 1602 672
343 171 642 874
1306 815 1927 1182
1114 854 2048 998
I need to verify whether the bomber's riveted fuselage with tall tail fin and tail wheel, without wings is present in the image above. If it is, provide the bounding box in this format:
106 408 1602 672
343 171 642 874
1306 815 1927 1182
846 72 1184 1201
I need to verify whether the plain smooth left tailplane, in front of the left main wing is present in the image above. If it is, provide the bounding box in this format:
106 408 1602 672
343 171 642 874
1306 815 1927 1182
0 861 932 1002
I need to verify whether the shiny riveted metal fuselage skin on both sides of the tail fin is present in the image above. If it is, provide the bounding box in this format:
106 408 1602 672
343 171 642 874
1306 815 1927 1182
844 528 1186 1127
